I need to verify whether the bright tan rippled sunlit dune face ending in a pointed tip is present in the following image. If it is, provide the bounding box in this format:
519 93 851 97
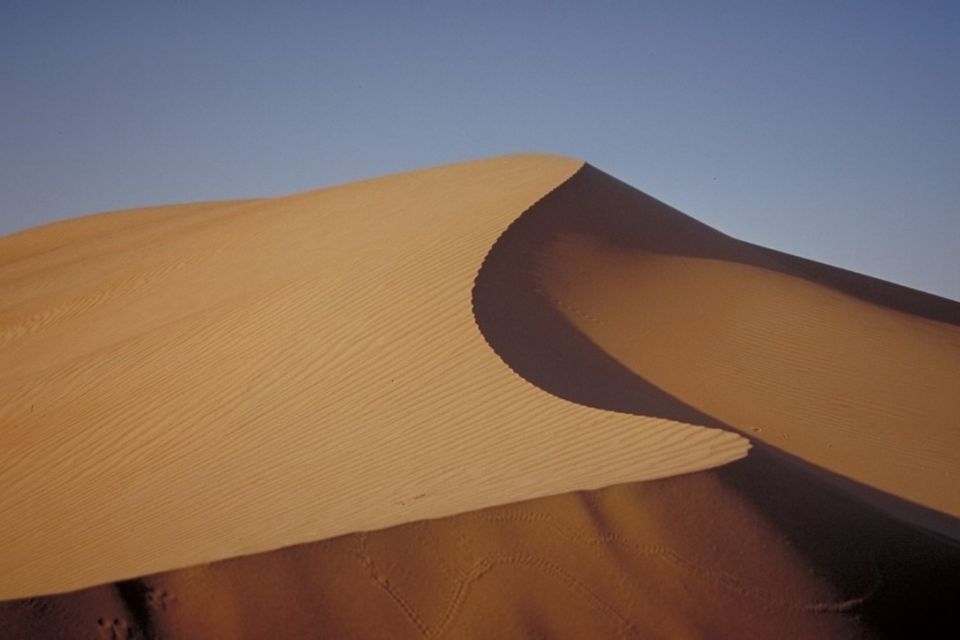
0 156 749 599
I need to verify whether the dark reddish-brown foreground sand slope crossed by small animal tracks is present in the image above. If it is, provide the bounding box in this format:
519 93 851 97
7 446 960 640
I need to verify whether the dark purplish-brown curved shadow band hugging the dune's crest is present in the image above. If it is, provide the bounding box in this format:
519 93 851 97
472 165 960 528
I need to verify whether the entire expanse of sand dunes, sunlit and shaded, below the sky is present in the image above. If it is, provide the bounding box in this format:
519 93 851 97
0 155 960 638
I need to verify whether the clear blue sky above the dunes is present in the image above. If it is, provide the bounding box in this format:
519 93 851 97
0 0 960 299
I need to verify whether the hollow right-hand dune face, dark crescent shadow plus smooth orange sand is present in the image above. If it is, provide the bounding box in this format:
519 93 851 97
474 166 960 537
